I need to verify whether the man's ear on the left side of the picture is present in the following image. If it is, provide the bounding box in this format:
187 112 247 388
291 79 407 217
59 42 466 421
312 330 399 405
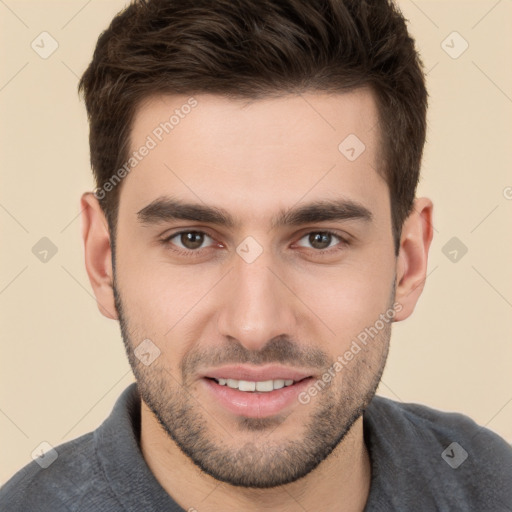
80 192 118 320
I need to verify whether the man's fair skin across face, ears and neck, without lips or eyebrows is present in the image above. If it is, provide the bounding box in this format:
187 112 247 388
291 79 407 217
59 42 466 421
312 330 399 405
81 89 433 512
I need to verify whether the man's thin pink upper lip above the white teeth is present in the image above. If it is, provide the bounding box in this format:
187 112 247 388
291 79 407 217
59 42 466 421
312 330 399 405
202 365 312 382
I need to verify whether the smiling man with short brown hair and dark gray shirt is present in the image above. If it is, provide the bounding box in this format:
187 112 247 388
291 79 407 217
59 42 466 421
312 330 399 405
0 0 512 512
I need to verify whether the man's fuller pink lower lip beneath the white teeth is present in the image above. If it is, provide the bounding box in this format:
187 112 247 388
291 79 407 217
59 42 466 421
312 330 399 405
201 377 313 418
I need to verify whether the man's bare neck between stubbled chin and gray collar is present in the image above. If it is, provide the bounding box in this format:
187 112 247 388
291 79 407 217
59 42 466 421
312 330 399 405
141 401 371 512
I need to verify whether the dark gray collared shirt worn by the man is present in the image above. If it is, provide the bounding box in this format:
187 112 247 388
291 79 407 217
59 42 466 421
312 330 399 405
0 383 512 512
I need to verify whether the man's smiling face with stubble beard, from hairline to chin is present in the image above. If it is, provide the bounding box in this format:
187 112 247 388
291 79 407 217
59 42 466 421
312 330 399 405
114 90 396 488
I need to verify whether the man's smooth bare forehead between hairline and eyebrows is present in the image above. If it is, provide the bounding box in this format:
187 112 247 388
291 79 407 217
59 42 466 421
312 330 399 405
120 89 387 228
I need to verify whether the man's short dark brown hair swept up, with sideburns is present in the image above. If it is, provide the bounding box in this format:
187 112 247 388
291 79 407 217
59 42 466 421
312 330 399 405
78 0 427 254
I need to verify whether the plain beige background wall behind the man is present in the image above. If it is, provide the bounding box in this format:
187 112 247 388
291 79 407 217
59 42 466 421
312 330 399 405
0 0 512 483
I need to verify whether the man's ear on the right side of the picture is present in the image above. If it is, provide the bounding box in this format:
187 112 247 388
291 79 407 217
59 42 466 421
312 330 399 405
395 197 434 322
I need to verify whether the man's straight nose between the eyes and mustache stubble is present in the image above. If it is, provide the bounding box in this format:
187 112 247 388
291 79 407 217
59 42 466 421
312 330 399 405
218 247 299 351
